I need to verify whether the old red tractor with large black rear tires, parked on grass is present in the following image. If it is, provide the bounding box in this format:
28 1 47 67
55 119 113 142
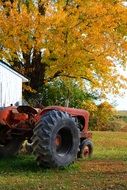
0 106 93 167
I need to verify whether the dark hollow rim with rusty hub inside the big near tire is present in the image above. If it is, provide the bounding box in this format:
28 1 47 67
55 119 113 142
55 128 73 156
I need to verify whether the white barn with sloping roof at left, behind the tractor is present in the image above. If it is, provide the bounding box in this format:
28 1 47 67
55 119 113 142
0 60 28 107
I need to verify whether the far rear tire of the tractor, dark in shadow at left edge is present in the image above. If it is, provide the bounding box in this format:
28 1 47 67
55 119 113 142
0 139 23 158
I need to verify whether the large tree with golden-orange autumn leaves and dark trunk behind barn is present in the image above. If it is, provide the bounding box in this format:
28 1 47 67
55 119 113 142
0 0 127 94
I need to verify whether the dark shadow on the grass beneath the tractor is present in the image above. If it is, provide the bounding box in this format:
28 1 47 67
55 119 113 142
0 155 79 174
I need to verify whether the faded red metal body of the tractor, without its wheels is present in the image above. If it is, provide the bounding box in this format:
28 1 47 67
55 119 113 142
0 106 92 144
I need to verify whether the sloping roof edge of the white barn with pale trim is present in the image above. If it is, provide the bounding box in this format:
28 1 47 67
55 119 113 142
0 60 29 82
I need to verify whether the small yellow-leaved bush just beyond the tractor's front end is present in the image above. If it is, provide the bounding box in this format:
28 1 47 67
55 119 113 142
82 100 117 131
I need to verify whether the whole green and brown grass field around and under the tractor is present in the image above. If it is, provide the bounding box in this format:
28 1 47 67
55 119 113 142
0 132 127 190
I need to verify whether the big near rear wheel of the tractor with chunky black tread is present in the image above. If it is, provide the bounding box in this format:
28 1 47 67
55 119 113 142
32 110 80 168
